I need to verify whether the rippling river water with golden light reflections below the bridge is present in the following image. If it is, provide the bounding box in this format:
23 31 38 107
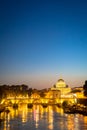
0 105 87 130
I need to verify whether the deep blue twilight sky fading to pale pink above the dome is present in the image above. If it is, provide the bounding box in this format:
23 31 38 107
0 0 87 89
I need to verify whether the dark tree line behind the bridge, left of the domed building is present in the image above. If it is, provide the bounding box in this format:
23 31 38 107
0 84 47 101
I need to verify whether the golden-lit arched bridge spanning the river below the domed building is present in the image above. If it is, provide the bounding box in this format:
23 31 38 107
2 97 76 105
